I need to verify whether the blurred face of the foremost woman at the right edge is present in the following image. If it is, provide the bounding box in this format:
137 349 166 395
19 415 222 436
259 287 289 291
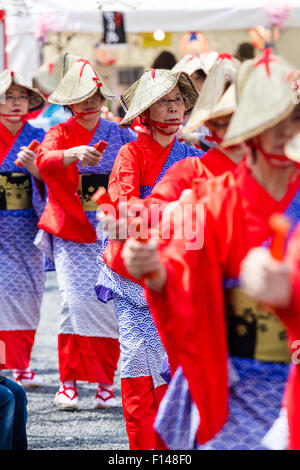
254 104 300 166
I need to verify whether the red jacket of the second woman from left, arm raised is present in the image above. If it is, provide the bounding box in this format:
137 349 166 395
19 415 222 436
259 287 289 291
37 117 102 243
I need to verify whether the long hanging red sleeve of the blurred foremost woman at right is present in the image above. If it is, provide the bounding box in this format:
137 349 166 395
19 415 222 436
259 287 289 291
145 201 228 443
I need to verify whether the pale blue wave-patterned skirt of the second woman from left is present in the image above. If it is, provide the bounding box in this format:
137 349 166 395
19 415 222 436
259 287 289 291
53 212 118 338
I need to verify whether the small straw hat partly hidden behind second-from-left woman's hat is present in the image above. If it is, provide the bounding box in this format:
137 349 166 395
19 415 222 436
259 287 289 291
33 55 63 95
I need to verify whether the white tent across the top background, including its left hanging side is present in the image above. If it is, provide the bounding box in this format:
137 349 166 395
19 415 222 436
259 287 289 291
0 0 300 80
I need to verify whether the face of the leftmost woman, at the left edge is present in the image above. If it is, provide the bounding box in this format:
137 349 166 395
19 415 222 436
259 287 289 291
0 83 29 122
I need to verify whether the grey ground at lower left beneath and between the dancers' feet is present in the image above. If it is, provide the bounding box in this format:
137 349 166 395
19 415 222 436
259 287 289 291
7 272 128 450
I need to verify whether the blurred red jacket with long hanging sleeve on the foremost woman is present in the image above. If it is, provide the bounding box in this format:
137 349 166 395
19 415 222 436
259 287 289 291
145 163 300 444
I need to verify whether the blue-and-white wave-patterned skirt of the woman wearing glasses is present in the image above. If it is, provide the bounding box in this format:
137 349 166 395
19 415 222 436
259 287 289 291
96 252 166 387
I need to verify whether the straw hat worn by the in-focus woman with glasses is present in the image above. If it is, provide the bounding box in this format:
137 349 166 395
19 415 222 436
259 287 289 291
119 69 198 127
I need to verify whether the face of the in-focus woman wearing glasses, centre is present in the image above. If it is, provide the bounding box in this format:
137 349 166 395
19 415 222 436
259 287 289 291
149 86 185 134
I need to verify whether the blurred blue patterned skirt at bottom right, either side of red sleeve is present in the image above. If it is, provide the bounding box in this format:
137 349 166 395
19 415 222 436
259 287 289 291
155 358 290 450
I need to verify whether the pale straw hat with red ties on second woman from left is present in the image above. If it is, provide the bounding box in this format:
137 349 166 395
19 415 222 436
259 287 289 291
48 53 116 105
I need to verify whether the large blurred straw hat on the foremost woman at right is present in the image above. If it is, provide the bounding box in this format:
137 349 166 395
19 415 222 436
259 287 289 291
222 49 299 146
